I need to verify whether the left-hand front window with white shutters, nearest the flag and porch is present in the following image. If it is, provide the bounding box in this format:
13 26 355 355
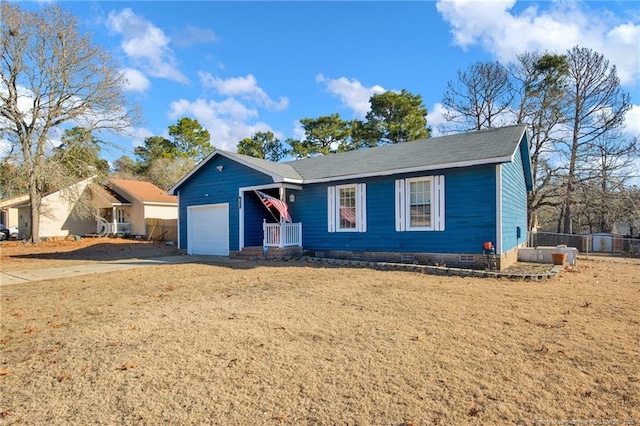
327 183 367 232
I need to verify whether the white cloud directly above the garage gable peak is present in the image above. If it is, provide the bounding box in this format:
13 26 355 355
169 98 275 151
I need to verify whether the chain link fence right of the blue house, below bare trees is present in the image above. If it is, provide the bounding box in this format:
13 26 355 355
529 232 640 259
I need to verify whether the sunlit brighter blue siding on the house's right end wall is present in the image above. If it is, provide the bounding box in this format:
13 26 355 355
501 140 527 252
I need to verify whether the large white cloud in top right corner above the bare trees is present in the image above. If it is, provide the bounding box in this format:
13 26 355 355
436 0 640 85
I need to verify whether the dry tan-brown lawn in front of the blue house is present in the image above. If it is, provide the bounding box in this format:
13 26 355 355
0 240 640 425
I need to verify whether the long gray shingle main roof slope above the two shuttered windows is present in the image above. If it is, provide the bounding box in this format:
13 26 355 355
283 125 526 182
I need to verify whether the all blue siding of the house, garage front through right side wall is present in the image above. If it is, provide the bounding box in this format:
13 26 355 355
171 138 531 254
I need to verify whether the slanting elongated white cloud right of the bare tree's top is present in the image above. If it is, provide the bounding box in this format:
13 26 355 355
107 8 189 83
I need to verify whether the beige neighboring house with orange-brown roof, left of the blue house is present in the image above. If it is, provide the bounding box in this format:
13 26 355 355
16 178 178 238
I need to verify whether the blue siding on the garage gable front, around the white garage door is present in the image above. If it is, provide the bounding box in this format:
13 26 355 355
177 155 273 250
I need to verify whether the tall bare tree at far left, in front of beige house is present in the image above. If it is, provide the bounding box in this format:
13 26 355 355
0 2 137 242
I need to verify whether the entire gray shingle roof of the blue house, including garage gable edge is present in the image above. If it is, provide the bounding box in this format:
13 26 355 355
169 125 527 193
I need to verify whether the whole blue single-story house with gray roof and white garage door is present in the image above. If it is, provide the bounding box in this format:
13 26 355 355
169 125 532 269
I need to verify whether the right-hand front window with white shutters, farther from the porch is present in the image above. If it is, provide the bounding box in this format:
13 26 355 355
395 175 445 232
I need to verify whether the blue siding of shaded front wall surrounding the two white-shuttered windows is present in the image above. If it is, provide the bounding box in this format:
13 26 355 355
292 165 496 253
